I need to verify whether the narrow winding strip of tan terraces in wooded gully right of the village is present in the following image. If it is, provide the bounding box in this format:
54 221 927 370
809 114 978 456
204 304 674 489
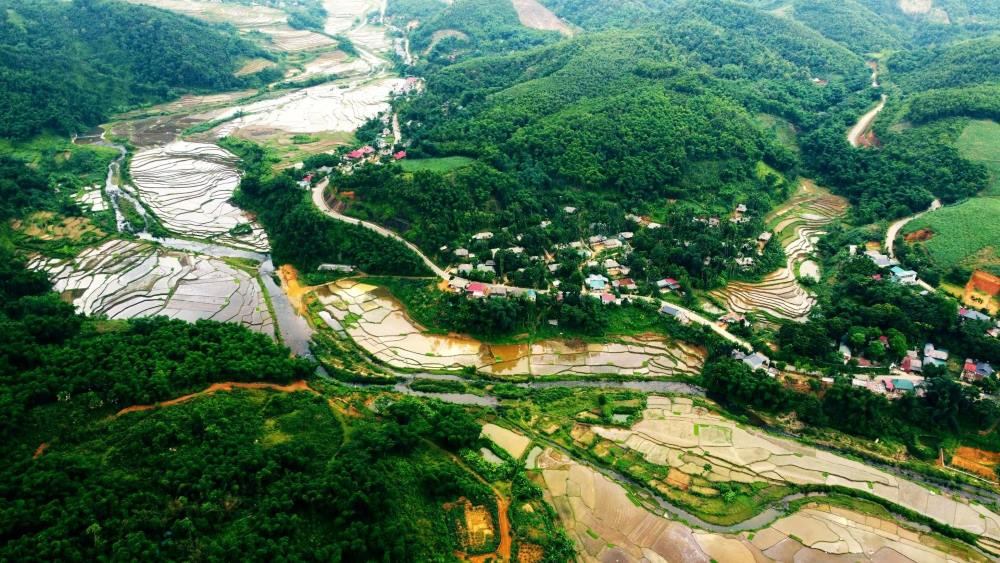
711 182 847 320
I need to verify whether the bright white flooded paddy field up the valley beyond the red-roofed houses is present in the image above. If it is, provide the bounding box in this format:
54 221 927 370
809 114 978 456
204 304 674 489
214 78 406 138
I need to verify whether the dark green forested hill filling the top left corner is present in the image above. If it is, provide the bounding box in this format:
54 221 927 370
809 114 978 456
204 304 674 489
0 0 256 137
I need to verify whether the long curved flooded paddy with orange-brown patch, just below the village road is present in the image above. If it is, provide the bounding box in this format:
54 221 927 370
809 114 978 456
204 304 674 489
316 280 704 377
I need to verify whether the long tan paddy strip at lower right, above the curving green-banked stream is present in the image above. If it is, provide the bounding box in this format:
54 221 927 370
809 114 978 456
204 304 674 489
591 396 1000 541
